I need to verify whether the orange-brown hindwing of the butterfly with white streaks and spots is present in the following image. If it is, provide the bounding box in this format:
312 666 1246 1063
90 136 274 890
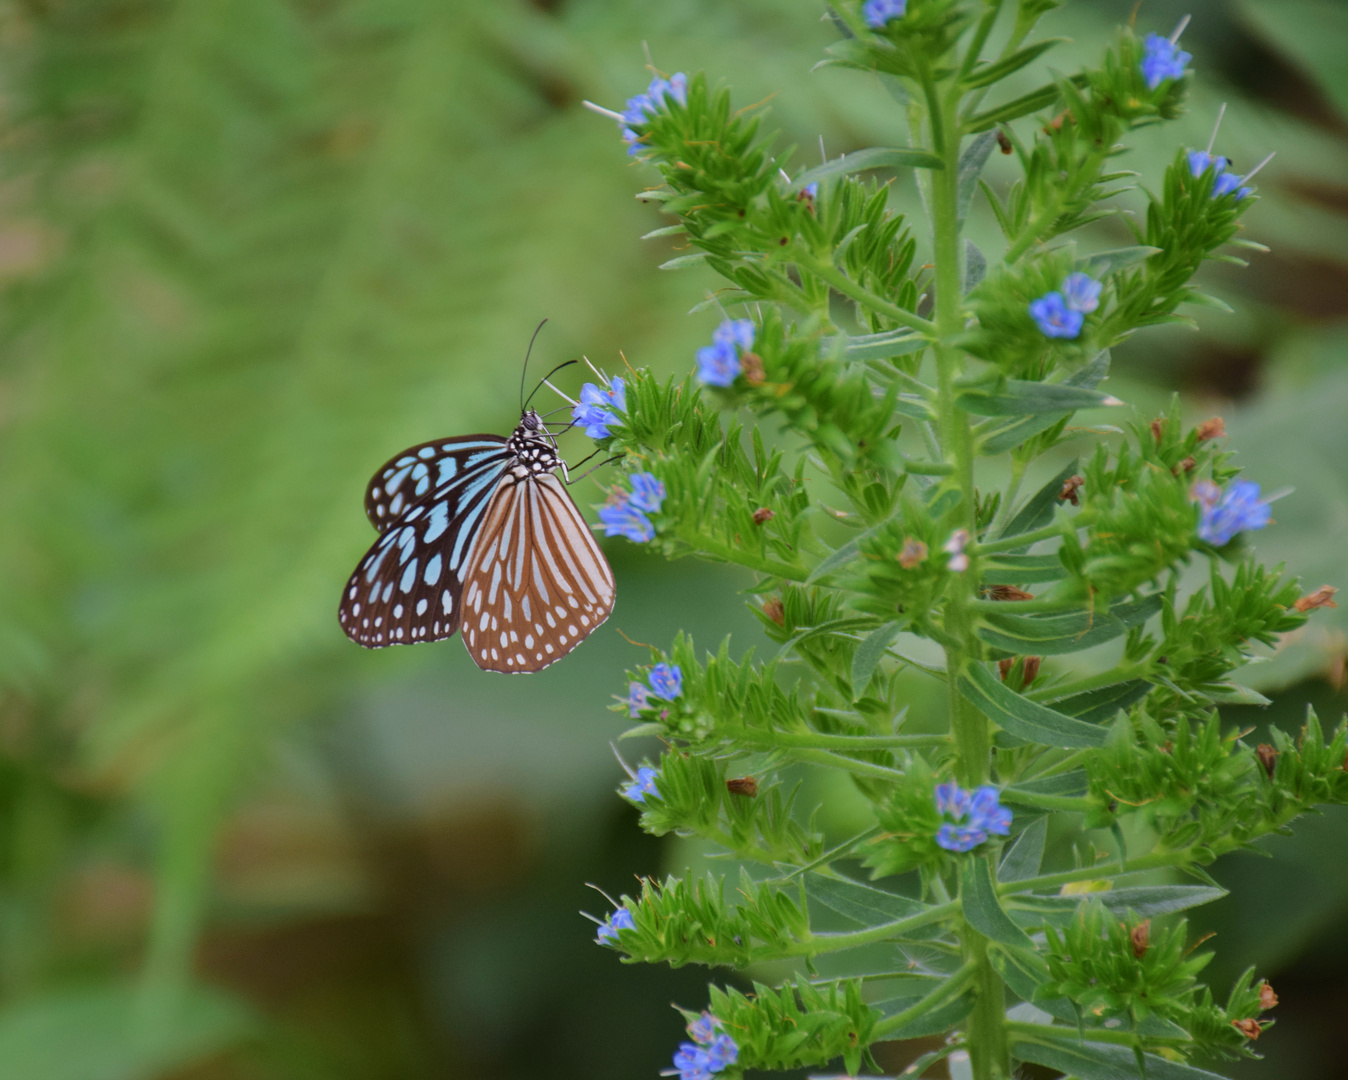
462 473 613 671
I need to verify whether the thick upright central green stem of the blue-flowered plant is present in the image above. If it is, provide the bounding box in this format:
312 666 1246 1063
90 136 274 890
921 56 1011 1080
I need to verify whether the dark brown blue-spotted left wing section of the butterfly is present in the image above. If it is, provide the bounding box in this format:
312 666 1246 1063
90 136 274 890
337 436 510 649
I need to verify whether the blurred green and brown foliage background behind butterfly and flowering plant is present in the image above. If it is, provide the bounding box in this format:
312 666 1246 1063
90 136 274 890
0 0 1348 1080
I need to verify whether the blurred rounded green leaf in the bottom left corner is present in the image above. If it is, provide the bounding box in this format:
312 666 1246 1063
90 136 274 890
0 983 257 1080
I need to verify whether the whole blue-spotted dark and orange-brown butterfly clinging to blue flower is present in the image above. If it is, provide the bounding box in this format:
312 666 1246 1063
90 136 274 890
337 409 615 671
